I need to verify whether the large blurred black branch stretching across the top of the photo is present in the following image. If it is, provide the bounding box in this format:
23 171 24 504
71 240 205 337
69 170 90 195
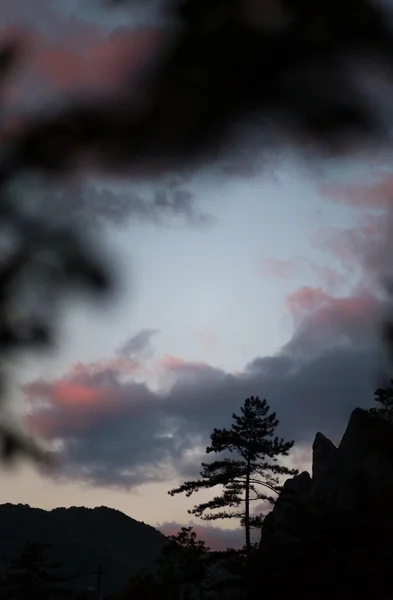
2 0 393 177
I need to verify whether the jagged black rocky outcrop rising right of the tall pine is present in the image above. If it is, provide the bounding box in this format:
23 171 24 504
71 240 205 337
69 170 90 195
253 409 393 600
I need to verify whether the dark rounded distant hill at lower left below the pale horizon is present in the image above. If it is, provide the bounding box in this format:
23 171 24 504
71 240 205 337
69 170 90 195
0 504 167 594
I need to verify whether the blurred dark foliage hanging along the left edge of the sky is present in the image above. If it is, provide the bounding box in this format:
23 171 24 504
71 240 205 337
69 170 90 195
0 46 110 465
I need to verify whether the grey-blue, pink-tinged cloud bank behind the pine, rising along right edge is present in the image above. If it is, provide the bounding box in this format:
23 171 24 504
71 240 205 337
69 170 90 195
19 170 393 489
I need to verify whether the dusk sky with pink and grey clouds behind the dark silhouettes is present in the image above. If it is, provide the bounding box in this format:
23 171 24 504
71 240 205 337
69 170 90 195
0 0 393 548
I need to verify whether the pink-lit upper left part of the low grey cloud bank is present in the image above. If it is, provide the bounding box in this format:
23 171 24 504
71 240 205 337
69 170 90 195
22 346 211 438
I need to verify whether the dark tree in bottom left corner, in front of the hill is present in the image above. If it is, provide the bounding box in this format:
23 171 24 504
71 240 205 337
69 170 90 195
4 541 77 600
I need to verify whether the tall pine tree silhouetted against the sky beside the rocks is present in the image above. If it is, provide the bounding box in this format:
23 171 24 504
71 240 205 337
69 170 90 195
168 396 297 556
